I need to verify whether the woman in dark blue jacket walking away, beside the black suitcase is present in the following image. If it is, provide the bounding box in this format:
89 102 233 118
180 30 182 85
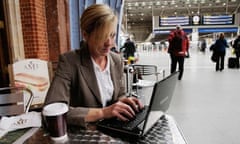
214 33 229 71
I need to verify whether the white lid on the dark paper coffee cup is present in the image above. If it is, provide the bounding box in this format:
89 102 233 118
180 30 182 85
42 102 68 116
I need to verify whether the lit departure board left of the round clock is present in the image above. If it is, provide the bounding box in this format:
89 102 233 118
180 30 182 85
159 16 190 26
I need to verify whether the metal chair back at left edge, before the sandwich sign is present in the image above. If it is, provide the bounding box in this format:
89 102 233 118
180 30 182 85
0 87 33 116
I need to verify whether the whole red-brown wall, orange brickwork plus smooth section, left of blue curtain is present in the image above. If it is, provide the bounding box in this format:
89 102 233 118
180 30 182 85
20 0 70 70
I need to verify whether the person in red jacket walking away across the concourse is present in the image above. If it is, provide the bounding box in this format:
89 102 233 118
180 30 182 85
168 25 189 80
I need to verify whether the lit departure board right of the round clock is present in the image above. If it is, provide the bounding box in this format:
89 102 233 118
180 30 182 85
203 15 234 25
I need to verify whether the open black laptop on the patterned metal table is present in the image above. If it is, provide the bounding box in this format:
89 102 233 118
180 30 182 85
97 72 178 137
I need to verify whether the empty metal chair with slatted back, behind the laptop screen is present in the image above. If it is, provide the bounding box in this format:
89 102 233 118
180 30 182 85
132 64 165 95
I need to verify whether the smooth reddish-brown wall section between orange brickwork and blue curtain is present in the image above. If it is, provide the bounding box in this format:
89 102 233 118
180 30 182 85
46 0 70 69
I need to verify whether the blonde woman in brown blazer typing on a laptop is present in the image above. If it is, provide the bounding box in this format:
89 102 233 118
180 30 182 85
45 4 143 126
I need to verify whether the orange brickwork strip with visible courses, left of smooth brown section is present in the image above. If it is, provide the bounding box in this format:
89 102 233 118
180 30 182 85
20 0 49 60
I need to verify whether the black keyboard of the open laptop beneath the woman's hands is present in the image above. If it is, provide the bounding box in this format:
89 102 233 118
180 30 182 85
98 106 148 131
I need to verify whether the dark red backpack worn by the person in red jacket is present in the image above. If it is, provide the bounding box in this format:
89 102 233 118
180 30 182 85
172 32 184 51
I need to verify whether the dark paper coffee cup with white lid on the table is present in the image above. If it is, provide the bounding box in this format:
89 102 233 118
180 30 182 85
42 102 68 141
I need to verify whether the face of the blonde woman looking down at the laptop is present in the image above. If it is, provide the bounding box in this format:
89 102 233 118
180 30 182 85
85 25 116 57
